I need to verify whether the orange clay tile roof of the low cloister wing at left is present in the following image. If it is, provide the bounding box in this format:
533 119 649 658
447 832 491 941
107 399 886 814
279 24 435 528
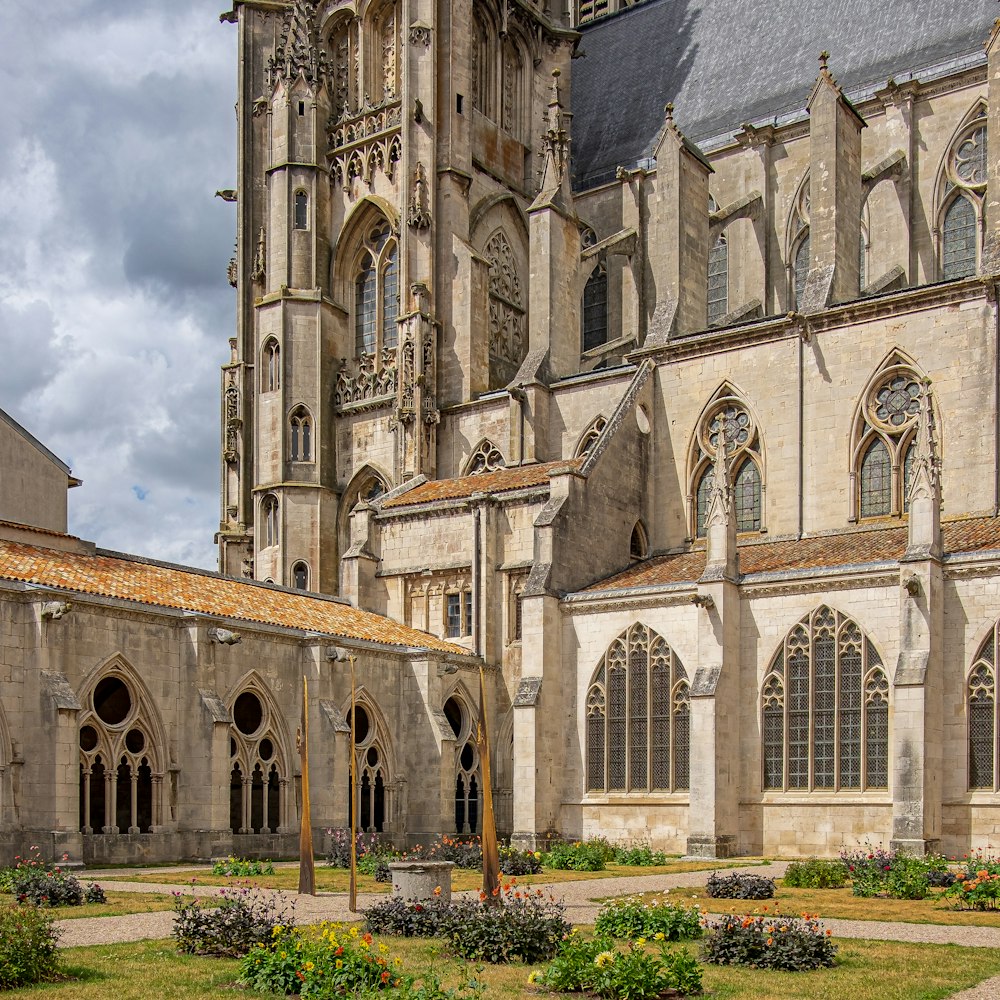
0 539 468 655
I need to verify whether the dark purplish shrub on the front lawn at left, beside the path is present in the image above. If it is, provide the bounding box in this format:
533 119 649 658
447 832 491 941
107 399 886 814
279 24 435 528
170 886 294 958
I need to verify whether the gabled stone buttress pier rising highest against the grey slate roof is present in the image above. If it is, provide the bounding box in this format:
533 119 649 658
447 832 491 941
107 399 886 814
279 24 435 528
801 52 865 313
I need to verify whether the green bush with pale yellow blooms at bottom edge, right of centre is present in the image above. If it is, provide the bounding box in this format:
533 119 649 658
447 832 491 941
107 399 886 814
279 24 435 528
530 934 701 1000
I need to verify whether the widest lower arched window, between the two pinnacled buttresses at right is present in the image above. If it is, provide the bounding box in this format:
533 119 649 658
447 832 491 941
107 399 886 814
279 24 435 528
761 605 889 791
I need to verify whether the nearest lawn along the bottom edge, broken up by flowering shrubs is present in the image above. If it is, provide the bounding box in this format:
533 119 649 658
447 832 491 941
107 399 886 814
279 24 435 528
11 938 1000 1000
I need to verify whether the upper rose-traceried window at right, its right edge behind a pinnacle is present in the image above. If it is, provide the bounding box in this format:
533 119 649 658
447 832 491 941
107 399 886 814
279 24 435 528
851 368 925 519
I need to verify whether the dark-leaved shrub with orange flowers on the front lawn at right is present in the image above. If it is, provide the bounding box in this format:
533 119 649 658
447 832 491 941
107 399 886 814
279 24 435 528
704 915 837 972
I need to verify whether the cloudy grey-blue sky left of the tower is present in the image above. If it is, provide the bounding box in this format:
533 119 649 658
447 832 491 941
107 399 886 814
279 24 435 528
0 0 236 568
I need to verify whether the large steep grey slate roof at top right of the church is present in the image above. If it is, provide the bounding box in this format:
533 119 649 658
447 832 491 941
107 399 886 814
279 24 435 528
572 0 1000 187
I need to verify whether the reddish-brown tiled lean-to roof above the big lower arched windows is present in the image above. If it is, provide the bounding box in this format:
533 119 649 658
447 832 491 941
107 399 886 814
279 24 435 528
584 517 1000 593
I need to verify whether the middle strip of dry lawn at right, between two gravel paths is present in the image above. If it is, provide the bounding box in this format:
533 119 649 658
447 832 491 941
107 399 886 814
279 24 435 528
664 880 1000 927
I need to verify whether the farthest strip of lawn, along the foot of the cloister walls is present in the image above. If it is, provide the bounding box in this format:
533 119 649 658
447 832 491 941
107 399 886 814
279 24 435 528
95 859 744 892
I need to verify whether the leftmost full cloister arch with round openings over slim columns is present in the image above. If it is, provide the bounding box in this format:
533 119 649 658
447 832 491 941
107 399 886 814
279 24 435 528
79 664 164 833
